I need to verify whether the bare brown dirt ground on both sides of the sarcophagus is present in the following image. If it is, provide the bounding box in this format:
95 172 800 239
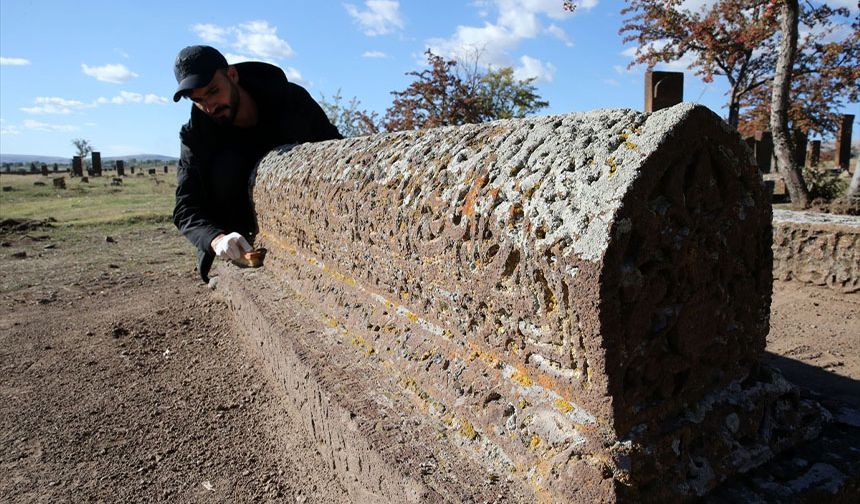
0 224 860 503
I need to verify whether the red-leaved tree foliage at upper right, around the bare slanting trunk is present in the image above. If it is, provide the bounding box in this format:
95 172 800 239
620 0 857 128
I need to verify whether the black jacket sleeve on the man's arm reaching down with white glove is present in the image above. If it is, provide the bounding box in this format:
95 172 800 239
173 142 226 254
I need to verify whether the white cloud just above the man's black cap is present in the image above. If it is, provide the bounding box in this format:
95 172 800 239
191 20 295 60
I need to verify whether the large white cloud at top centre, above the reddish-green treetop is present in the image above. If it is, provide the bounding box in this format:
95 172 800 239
426 0 580 74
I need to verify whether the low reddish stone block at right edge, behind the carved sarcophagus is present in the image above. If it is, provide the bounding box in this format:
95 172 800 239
773 210 860 292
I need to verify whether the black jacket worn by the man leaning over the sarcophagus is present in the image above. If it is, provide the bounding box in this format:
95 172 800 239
173 62 343 258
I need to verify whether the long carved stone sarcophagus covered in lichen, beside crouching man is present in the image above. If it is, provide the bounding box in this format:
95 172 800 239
224 104 836 502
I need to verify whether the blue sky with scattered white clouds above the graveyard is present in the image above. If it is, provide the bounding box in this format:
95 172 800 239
0 0 860 156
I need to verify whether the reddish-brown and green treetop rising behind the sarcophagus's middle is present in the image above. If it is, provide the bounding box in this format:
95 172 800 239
383 50 549 131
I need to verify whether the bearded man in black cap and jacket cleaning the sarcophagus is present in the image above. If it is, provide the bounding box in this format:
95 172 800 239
173 46 343 281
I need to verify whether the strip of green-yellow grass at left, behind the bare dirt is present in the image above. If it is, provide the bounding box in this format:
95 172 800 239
0 174 176 226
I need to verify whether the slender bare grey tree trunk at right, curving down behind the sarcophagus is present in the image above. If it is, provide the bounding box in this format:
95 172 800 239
770 0 809 208
